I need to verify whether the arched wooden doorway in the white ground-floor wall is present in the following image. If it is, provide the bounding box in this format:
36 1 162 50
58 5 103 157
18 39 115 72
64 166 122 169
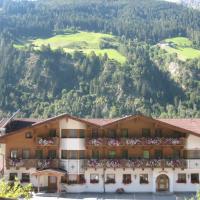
156 174 169 192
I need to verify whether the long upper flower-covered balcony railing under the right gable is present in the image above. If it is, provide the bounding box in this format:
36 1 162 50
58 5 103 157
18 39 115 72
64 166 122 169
86 137 185 147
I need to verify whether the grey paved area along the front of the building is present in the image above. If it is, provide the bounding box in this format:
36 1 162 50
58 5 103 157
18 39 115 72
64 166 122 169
32 193 195 200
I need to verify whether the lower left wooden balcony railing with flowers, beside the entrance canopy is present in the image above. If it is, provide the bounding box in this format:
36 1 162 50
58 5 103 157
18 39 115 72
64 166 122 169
6 159 59 169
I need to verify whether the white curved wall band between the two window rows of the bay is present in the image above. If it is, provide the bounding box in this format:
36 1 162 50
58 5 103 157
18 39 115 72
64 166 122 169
60 138 85 150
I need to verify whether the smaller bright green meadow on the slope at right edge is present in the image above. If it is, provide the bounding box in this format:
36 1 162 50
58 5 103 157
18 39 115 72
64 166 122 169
160 37 200 61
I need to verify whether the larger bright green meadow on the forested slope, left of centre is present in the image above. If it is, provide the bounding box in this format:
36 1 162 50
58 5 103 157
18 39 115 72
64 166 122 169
15 31 126 63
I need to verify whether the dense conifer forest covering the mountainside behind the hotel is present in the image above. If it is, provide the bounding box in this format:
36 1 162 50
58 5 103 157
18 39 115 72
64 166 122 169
0 0 200 118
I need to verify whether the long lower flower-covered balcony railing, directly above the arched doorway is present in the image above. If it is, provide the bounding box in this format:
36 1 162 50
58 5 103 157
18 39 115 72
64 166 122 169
86 159 187 169
